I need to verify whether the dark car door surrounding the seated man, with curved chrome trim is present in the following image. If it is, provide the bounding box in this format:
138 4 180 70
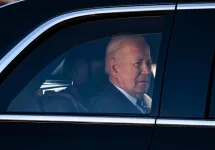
0 2 175 149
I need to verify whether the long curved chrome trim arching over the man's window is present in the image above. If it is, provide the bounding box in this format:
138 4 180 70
0 5 175 73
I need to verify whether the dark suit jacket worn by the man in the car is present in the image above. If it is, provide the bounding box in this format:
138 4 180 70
91 83 142 114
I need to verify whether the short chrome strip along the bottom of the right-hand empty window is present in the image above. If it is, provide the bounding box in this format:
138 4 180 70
156 118 215 127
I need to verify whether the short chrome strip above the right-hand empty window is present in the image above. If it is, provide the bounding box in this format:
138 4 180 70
177 3 215 10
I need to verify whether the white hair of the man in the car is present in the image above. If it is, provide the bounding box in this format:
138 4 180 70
105 35 148 74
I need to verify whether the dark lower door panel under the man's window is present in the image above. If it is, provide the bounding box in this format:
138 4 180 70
0 122 153 150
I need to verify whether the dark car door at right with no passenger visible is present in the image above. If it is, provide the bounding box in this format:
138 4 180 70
151 1 215 150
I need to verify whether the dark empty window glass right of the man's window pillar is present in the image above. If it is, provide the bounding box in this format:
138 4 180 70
161 10 215 118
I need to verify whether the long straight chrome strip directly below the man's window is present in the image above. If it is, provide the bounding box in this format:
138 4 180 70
0 115 155 125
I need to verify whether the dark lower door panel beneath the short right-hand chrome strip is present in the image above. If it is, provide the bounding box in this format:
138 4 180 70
151 125 215 150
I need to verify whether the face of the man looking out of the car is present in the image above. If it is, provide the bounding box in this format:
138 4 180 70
117 42 152 95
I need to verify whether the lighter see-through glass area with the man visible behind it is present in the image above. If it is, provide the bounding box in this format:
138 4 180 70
8 34 162 115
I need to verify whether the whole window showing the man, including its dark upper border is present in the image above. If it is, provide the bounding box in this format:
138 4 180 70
0 10 173 116
